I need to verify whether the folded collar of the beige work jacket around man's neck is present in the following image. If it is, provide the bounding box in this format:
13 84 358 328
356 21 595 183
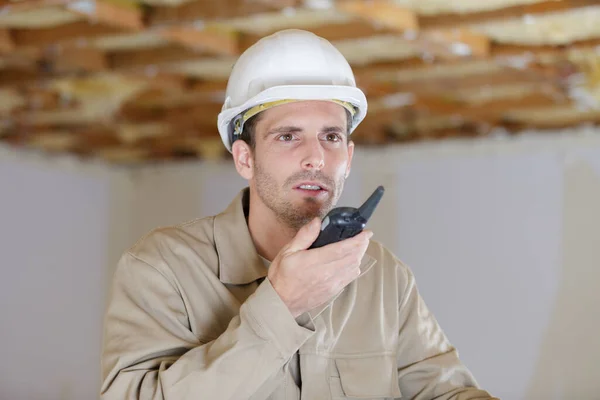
214 188 375 285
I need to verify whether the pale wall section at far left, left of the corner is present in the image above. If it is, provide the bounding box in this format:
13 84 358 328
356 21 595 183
0 148 125 400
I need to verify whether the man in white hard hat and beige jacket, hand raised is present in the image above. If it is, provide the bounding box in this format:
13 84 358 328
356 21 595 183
101 30 492 400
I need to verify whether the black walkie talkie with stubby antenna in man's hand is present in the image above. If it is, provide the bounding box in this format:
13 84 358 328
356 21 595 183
309 186 384 249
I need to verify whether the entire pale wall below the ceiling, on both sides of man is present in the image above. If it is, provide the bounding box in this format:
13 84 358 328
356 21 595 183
0 131 600 400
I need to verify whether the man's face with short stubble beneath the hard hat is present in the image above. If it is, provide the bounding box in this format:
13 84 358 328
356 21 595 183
241 101 354 229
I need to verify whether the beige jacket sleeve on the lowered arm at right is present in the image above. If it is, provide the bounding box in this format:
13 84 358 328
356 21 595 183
397 262 497 400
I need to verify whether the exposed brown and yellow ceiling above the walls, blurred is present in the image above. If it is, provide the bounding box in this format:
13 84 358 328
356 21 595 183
0 0 600 163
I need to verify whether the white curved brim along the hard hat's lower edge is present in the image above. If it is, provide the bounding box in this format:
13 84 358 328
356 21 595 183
217 85 367 152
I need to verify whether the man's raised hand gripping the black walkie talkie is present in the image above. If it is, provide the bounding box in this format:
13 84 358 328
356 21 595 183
268 218 373 317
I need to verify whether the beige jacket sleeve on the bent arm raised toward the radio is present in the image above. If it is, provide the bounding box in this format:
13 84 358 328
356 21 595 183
101 253 314 400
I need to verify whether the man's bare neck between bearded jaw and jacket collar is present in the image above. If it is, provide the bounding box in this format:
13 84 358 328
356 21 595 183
248 189 296 261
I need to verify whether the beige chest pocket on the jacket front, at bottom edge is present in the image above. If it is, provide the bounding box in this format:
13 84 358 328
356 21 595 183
329 355 402 400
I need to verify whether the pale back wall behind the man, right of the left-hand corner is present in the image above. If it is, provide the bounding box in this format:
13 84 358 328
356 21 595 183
122 130 600 400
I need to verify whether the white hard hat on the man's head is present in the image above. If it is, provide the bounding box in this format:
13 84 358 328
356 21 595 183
218 29 367 151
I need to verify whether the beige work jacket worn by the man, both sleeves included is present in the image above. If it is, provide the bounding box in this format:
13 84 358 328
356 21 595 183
101 189 492 400
